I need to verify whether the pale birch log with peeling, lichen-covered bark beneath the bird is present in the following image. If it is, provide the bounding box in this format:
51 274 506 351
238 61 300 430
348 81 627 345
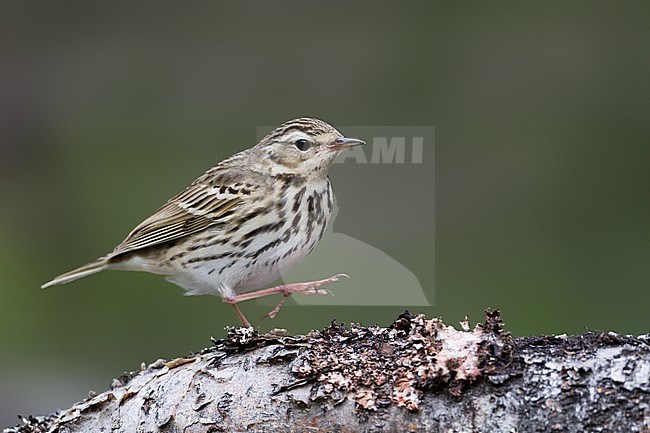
5 312 650 433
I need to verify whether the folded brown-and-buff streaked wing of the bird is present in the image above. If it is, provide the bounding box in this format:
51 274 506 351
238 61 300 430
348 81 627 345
109 168 253 258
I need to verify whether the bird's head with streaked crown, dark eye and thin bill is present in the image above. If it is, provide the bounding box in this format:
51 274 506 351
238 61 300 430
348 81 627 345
252 117 365 177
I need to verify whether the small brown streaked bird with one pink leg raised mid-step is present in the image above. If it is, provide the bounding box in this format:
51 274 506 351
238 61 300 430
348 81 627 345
41 117 365 327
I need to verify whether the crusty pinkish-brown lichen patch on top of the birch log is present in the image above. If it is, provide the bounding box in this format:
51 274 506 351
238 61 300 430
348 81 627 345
291 311 510 410
